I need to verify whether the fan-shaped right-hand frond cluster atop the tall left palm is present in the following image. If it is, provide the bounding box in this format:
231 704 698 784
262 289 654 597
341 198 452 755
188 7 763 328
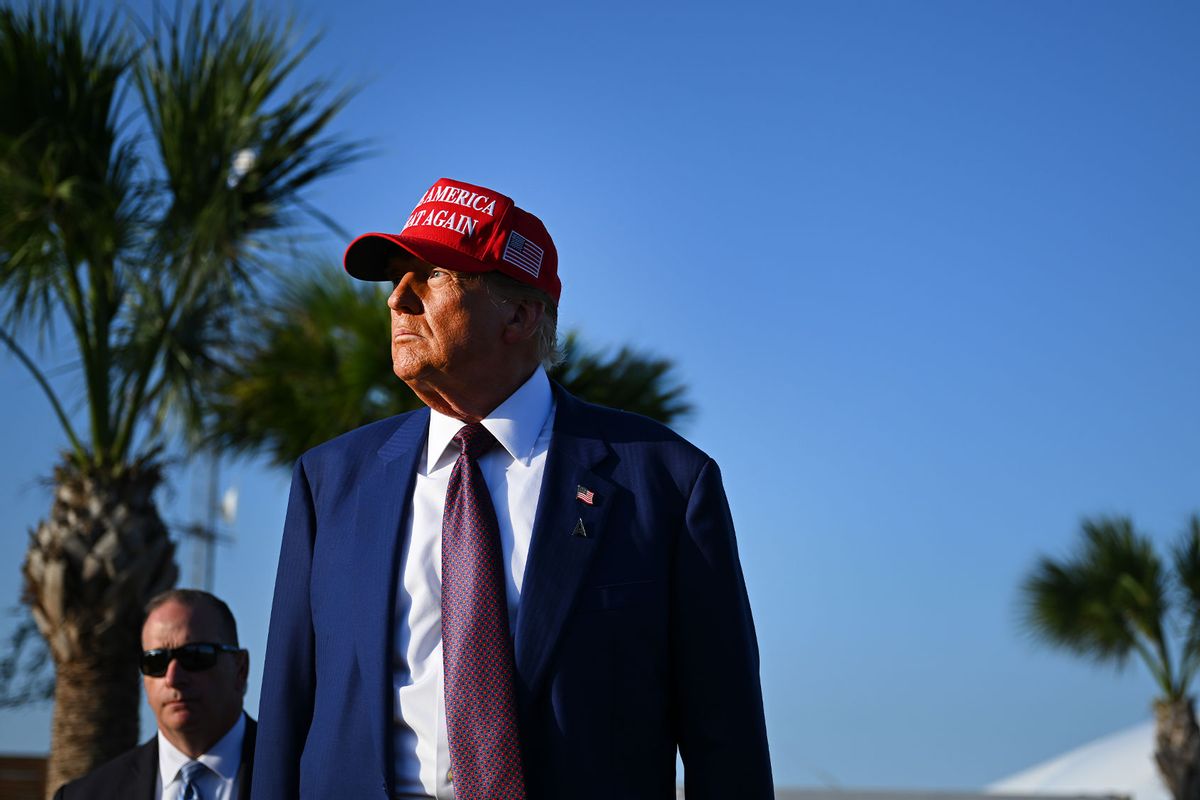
137 4 362 281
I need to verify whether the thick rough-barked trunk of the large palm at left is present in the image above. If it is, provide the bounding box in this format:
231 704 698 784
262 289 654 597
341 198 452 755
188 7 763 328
24 458 178 798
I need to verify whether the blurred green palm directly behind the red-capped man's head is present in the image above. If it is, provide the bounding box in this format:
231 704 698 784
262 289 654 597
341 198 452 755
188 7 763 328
212 269 691 467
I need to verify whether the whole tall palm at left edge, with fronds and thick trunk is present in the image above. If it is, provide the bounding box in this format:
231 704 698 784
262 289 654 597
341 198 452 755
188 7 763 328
0 0 359 792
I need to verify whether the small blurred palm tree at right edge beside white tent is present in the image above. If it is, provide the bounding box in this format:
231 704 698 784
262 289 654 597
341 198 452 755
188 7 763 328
1022 516 1200 800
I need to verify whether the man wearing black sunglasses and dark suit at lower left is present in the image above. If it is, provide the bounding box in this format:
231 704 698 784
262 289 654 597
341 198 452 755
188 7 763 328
54 589 256 800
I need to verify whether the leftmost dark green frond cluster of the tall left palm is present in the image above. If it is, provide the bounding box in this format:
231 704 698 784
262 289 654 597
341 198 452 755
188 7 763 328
0 2 137 461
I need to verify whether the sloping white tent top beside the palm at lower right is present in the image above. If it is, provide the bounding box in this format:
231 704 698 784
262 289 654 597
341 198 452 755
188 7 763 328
986 722 1171 800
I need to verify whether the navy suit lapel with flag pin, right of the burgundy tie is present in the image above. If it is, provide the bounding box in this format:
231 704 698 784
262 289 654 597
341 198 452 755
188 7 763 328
514 384 616 697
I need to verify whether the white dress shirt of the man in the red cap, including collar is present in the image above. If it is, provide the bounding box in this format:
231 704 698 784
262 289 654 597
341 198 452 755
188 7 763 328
392 367 554 800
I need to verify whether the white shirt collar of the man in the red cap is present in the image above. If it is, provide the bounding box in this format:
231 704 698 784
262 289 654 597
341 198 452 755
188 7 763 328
425 367 554 475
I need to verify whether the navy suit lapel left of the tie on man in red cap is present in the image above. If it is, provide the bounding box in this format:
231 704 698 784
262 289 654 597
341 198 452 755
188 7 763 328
349 409 430 786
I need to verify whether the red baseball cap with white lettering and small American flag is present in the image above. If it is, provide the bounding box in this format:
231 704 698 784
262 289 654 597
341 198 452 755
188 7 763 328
342 178 563 302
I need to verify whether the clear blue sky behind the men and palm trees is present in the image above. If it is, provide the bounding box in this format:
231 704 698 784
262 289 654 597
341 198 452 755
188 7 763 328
0 0 1200 788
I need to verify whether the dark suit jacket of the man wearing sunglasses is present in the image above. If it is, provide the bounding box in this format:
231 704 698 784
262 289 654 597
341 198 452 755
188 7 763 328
54 716 257 800
